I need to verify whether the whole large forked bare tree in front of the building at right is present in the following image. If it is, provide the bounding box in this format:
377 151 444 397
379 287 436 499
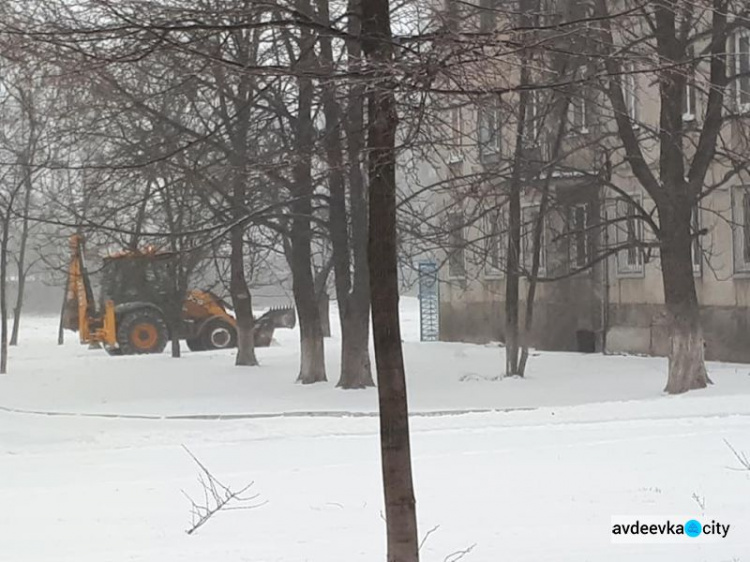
595 0 747 394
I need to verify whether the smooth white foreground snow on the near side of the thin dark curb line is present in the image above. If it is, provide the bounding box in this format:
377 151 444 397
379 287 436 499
0 399 750 562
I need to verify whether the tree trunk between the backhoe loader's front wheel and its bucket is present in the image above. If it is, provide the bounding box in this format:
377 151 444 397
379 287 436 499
229 225 258 367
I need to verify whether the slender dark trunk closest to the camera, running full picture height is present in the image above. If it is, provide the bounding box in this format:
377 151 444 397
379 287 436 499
362 0 419 562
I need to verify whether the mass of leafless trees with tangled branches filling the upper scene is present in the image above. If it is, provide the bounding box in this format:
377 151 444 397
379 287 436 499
0 0 750 561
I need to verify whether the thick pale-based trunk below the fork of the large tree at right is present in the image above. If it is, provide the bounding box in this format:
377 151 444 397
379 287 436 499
659 203 710 394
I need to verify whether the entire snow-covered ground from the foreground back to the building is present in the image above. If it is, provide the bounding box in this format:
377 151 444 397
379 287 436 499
0 299 750 562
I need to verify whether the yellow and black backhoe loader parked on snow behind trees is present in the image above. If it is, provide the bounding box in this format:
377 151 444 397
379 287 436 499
63 235 296 355
